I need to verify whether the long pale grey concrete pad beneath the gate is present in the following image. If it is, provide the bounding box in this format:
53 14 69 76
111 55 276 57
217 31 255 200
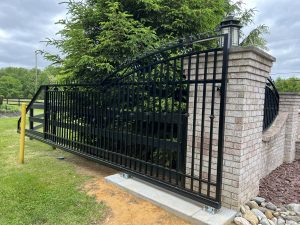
105 174 236 225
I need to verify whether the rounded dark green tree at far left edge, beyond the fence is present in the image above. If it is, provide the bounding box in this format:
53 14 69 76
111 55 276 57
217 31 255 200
0 76 23 98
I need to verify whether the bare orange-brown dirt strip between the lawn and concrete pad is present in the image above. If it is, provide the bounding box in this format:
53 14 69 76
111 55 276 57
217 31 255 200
66 157 191 225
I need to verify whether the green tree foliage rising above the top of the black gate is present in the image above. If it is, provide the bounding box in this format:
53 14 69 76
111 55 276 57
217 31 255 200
45 0 266 81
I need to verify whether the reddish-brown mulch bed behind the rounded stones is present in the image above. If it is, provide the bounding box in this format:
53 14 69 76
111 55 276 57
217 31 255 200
259 160 300 206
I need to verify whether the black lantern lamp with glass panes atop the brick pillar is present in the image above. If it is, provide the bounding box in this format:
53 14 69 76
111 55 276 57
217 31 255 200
220 15 242 48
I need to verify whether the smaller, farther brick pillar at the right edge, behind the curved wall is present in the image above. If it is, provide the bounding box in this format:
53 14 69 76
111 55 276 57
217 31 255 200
279 93 300 162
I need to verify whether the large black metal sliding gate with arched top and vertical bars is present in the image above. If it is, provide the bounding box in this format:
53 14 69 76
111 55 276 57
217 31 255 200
18 35 228 208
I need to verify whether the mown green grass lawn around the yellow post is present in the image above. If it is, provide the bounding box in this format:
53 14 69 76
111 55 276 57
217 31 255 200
0 118 105 225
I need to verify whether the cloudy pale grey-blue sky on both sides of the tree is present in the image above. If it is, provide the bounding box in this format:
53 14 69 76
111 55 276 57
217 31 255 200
0 0 300 78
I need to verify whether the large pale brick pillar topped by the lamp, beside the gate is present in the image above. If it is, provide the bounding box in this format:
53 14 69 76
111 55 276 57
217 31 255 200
222 47 275 209
